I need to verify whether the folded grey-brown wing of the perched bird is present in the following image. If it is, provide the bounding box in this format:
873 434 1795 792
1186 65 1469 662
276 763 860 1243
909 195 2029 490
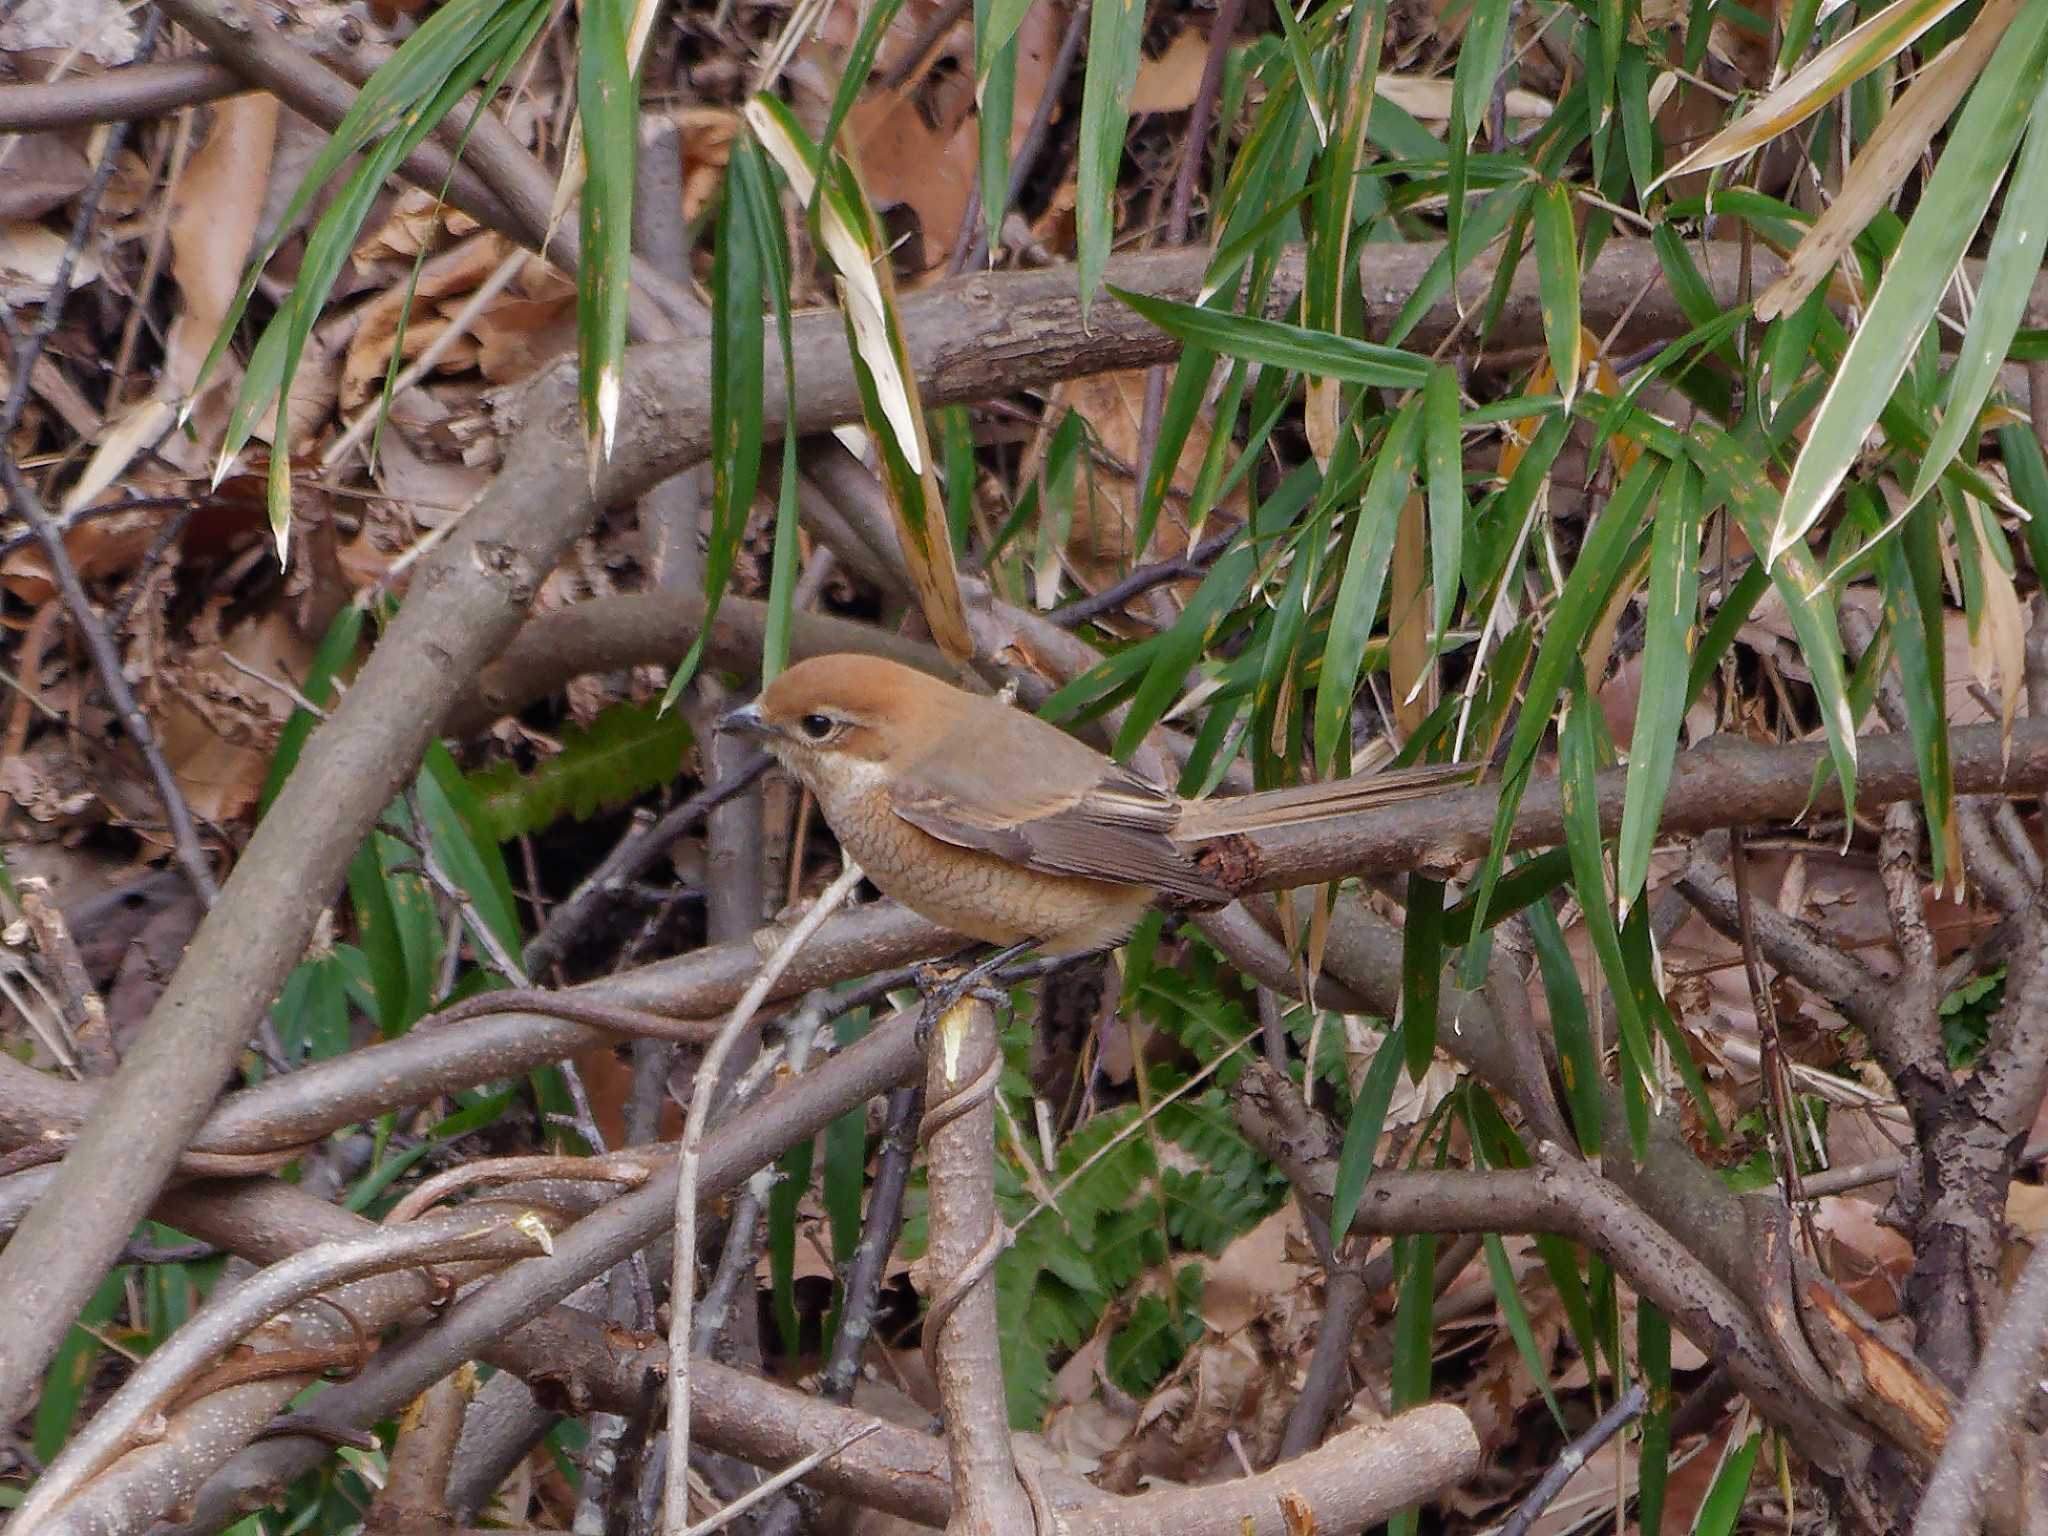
889 753 1231 903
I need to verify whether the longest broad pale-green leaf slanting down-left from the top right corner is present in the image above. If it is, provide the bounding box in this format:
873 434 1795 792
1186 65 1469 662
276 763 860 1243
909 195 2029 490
1765 6 2048 565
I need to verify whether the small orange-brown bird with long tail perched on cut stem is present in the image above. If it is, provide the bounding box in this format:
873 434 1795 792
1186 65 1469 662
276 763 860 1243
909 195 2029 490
719 655 1473 954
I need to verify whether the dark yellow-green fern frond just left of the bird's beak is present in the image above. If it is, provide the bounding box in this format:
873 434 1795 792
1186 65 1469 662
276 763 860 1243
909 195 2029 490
469 705 694 842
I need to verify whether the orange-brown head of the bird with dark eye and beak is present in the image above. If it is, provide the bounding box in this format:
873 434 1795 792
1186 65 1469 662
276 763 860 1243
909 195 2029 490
719 655 967 797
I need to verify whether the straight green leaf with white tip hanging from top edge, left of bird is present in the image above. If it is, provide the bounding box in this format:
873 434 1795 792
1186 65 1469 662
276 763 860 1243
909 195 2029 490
575 0 639 466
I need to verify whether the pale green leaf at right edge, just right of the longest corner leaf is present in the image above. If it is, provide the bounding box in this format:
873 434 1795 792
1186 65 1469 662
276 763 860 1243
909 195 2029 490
1900 86 2048 502
